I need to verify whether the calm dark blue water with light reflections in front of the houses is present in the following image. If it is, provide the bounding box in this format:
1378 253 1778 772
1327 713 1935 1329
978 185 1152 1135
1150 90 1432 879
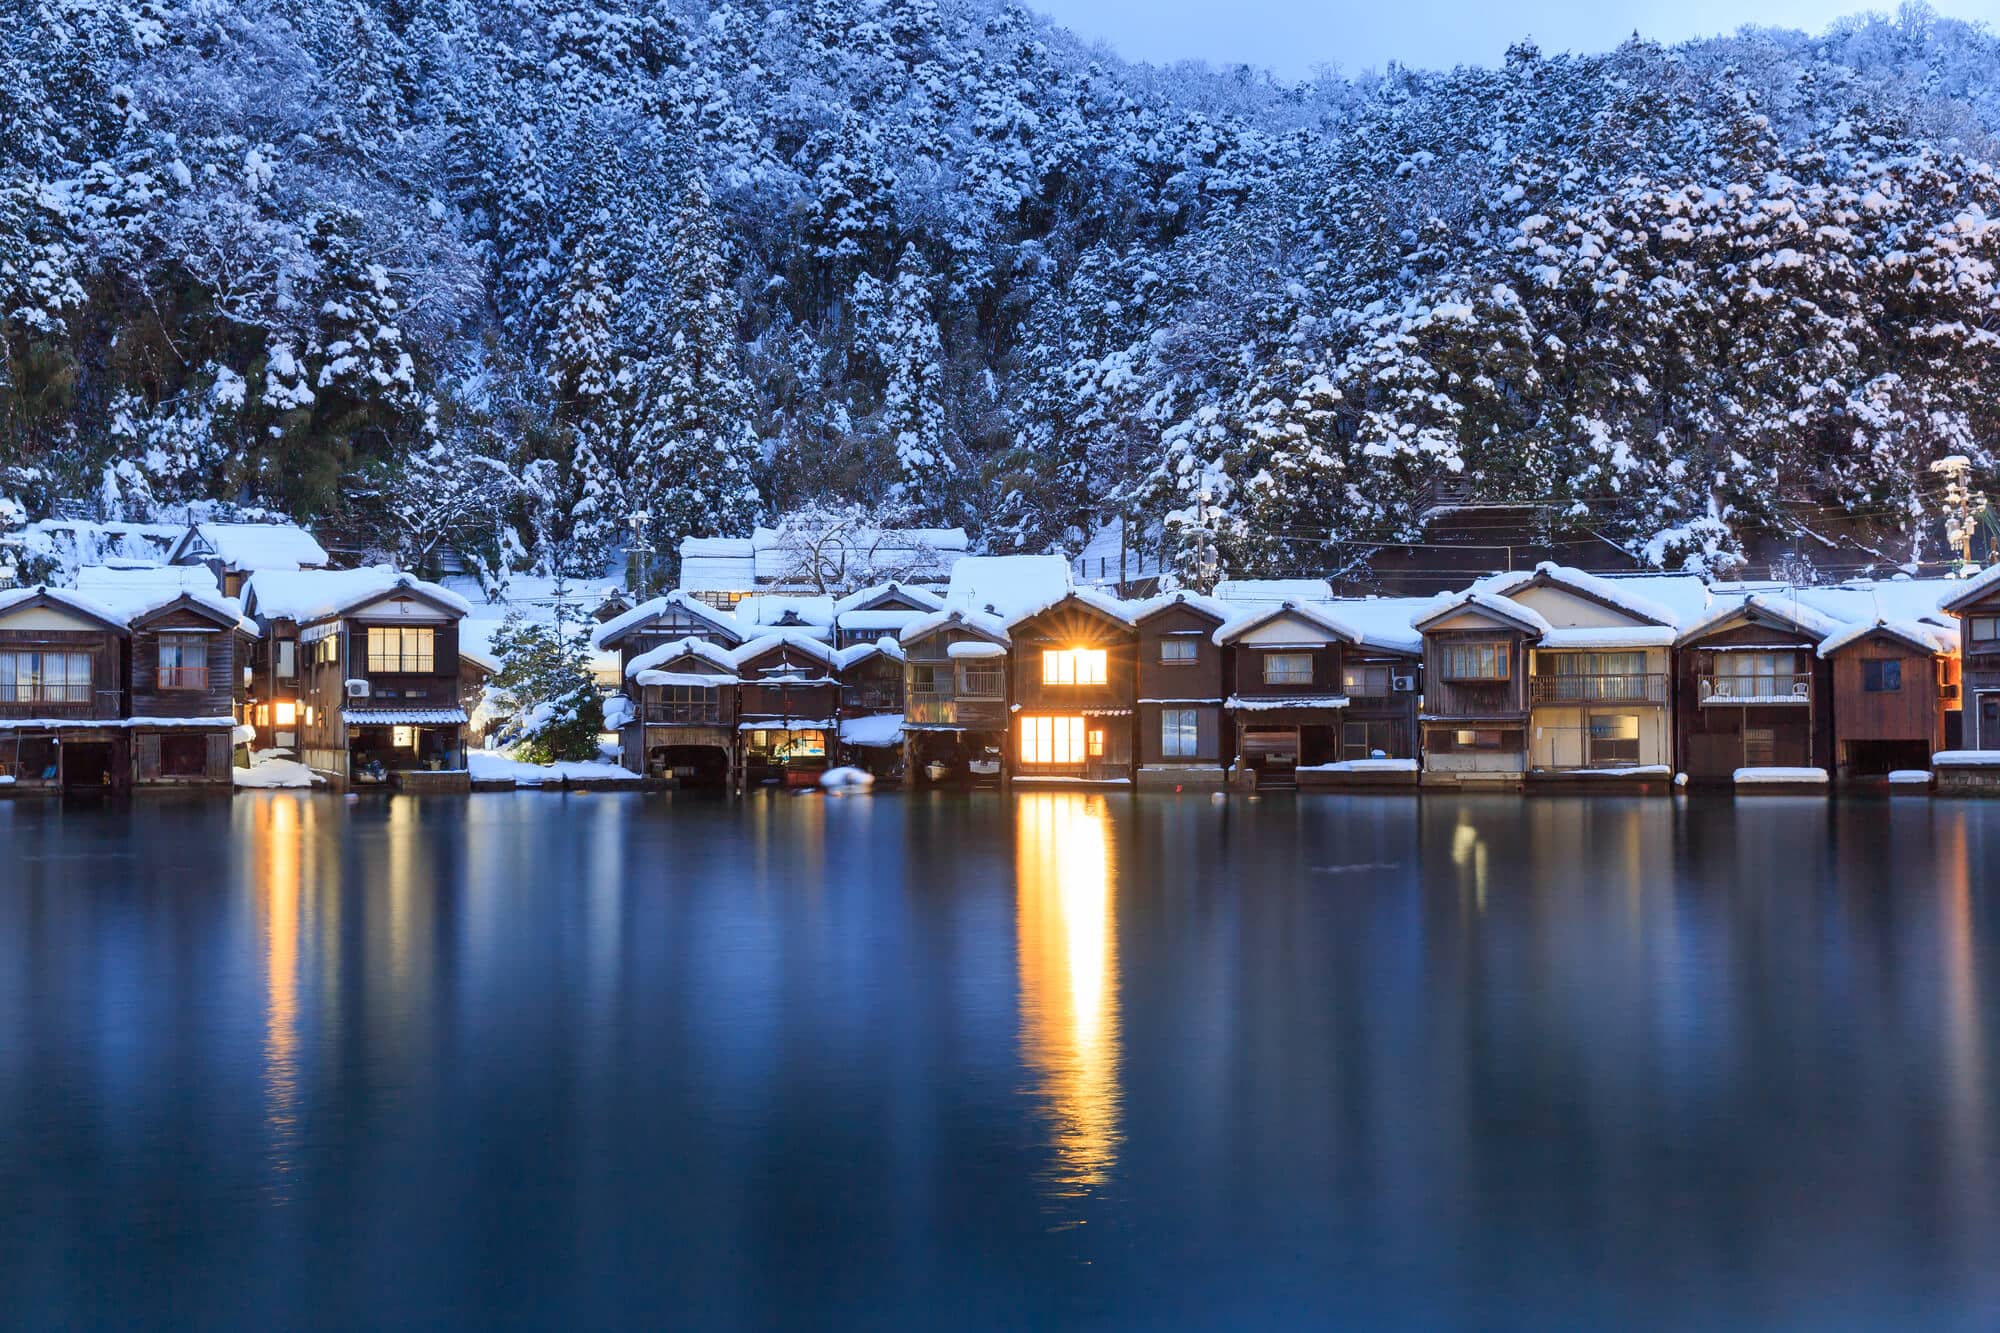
0 793 2000 1329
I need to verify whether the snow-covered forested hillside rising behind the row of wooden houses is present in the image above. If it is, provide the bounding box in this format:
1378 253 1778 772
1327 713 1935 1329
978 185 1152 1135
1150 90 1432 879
0 0 2000 574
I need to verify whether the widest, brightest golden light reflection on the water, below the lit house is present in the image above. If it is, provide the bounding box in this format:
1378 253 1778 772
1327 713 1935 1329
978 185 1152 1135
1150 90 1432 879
1014 793 1120 1199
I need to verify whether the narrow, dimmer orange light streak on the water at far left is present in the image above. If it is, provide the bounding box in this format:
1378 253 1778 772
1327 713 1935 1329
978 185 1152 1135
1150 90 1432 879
254 793 312 1201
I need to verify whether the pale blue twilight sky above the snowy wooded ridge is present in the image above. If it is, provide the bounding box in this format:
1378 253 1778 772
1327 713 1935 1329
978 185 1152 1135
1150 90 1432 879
1030 0 2000 78
